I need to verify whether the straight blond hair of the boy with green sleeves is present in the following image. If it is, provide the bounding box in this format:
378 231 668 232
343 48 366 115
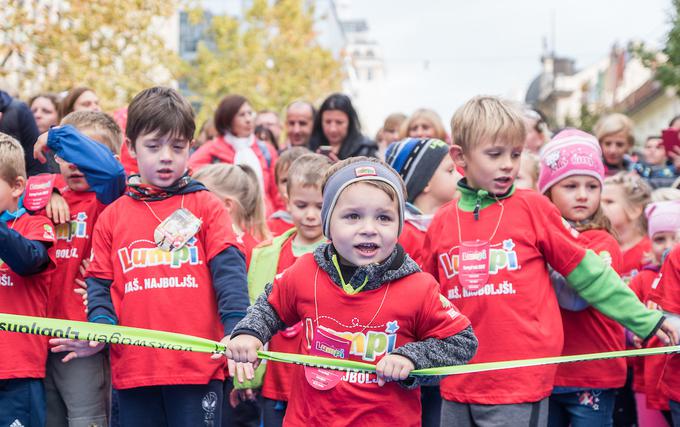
451 96 526 153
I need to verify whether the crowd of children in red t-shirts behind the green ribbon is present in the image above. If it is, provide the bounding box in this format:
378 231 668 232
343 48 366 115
0 87 680 427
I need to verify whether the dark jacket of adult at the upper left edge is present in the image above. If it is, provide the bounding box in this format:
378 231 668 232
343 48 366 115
0 90 48 176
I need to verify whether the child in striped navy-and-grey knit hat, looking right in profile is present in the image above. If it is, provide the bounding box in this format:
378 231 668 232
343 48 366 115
385 138 461 261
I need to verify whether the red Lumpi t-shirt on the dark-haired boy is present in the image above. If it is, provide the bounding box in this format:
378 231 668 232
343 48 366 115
87 191 240 389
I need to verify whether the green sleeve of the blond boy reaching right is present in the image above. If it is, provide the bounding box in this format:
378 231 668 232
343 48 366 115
567 250 663 338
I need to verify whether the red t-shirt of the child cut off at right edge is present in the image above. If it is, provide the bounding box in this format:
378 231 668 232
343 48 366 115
649 246 680 402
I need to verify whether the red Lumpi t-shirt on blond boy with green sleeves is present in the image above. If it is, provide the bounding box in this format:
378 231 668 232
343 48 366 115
422 190 585 404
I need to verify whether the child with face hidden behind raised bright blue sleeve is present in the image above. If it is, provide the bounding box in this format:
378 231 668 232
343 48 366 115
36 111 125 427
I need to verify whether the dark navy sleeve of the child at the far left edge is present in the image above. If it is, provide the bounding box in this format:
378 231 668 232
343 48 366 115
0 222 50 276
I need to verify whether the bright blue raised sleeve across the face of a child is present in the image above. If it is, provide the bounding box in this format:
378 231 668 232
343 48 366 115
47 125 125 205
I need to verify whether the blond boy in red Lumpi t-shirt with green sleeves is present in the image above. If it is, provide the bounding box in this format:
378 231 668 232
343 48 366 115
422 97 676 426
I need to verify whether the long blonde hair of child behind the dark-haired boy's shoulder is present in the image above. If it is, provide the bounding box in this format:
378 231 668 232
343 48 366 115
193 163 270 240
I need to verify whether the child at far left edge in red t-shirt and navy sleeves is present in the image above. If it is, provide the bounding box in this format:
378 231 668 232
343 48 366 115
0 133 55 426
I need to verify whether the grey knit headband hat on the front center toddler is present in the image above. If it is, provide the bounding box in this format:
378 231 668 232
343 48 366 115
321 160 405 239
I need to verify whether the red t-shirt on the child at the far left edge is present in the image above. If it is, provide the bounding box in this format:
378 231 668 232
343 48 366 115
0 214 55 380
